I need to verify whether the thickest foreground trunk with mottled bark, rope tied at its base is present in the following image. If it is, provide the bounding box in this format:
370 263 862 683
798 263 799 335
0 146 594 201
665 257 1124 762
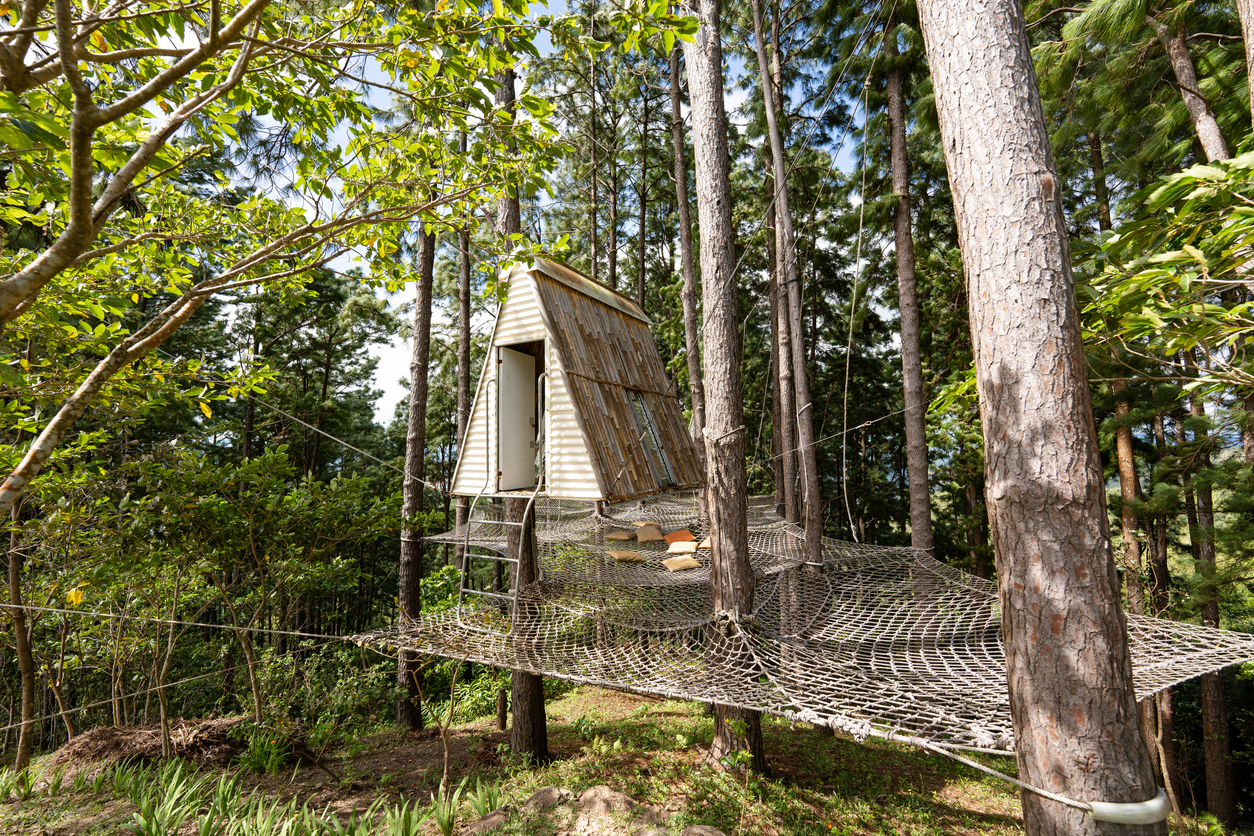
919 0 1166 836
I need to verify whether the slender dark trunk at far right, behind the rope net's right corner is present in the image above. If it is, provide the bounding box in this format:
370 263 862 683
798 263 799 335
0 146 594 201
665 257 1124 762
1185 381 1236 827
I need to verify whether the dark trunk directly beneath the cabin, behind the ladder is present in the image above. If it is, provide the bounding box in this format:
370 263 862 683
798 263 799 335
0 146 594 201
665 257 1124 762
509 499 553 766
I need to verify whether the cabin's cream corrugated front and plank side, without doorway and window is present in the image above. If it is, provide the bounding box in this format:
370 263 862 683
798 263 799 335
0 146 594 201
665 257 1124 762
453 259 705 501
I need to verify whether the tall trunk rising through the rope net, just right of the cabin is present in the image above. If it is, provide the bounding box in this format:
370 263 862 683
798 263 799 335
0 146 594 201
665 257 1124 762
683 0 766 772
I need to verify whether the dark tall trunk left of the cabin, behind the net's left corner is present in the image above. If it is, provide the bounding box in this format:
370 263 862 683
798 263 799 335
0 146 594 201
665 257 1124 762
396 229 435 728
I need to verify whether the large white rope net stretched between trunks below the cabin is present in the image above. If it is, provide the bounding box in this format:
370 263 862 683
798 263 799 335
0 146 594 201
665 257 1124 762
352 493 1254 752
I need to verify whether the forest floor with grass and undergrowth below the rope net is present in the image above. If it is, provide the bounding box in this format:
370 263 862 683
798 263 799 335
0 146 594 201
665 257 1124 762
0 688 1223 836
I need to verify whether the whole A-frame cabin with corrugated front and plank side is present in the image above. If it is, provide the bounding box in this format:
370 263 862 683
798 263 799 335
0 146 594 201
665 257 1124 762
453 258 703 503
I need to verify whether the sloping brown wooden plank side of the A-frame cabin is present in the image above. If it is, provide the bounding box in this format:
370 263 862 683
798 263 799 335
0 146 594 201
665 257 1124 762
532 271 703 501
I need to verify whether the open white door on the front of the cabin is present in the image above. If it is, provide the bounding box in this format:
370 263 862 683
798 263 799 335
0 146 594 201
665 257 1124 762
497 346 535 491
